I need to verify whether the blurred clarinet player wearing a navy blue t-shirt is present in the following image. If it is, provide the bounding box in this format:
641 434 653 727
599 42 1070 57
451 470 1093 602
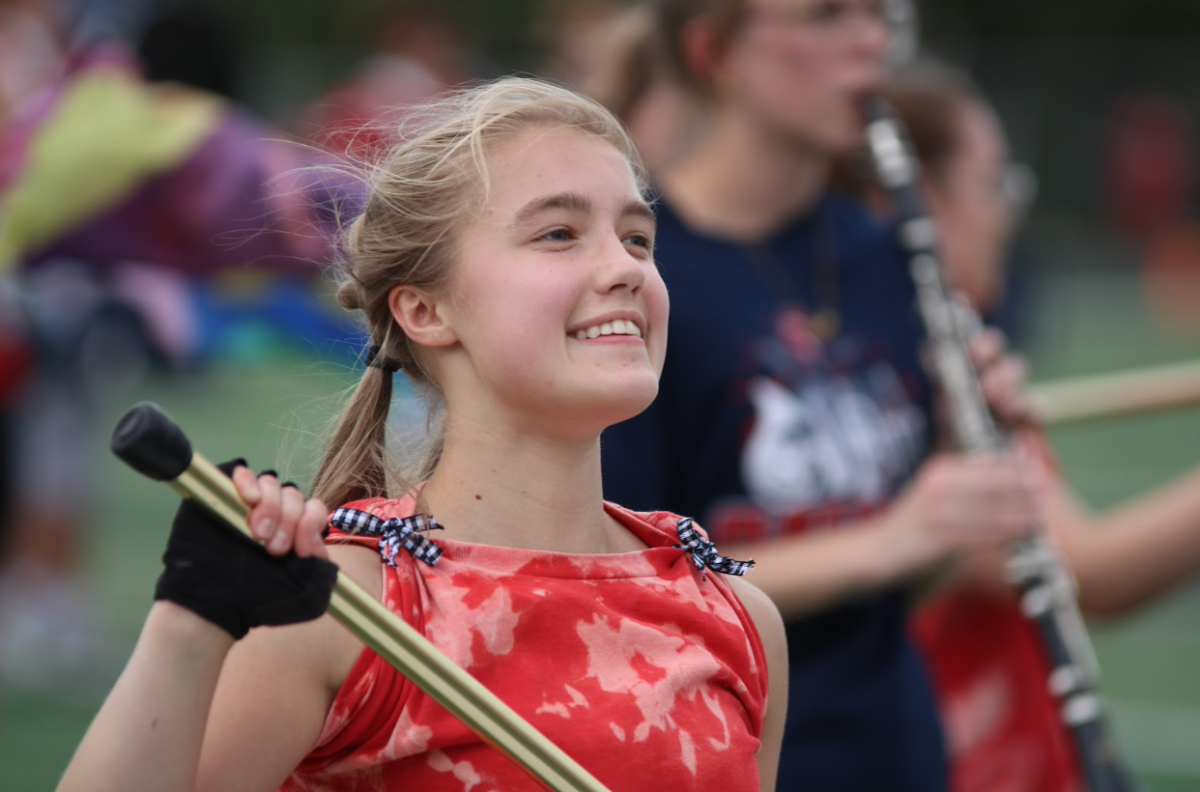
585 0 1036 792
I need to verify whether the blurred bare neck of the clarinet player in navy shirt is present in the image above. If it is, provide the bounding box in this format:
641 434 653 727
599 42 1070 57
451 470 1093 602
659 113 830 242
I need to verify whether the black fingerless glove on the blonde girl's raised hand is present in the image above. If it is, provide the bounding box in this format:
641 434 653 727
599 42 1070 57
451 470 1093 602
155 460 337 640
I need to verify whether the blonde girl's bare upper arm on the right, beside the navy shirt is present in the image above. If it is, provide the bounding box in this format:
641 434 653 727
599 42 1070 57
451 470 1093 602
728 577 787 792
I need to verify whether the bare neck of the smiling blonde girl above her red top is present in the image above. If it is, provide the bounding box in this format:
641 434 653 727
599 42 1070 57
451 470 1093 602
422 427 638 553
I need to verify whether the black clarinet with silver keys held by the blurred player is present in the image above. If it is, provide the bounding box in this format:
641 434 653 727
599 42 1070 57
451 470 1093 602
866 97 1138 792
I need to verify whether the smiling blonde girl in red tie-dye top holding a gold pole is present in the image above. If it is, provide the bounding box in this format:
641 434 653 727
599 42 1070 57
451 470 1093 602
60 78 786 792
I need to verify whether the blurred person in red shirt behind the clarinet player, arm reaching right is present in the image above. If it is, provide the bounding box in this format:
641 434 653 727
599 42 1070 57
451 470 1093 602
863 59 1200 792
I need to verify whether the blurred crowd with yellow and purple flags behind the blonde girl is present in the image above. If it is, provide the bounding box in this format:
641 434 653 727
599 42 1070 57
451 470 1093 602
0 0 468 688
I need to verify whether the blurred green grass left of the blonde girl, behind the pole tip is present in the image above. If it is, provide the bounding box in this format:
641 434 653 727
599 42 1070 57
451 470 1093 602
0 361 360 792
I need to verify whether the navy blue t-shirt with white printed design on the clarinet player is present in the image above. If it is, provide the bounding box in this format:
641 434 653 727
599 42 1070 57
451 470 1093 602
601 194 947 792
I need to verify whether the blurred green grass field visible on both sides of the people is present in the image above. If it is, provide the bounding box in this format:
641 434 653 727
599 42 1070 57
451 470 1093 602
0 268 1200 792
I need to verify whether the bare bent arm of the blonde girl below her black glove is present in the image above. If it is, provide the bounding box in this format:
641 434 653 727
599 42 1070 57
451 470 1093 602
59 547 380 792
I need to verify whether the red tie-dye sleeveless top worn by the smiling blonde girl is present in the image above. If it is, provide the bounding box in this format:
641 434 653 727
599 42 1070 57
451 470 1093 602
282 498 767 792
